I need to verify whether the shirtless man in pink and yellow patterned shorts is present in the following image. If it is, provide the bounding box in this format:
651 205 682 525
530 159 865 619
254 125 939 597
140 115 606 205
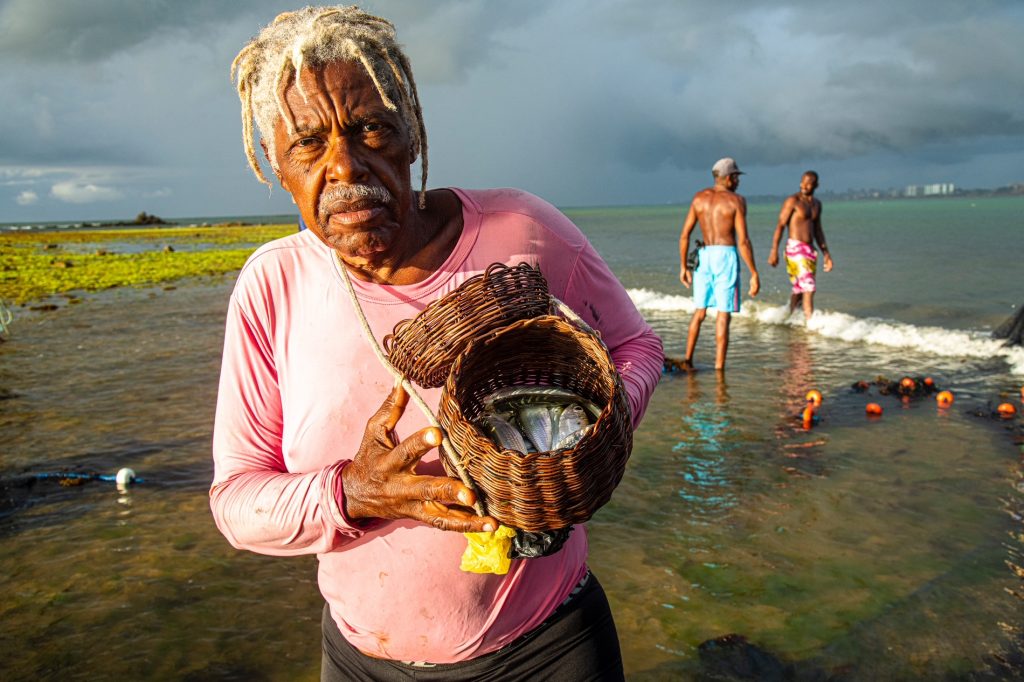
768 171 833 321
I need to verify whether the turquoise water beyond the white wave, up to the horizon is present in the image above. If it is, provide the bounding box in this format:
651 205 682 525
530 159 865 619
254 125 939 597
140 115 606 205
569 197 1024 330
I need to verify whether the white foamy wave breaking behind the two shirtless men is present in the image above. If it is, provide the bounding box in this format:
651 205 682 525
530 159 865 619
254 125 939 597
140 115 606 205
629 289 1024 375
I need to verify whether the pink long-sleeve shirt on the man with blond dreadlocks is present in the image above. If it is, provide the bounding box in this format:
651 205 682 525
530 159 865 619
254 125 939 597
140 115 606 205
210 189 664 663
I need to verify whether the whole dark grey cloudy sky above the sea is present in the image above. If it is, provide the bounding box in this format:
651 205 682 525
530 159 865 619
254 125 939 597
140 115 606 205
0 0 1024 219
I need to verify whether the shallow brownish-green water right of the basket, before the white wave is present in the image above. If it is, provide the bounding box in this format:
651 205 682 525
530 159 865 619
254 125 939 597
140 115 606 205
592 311 1021 680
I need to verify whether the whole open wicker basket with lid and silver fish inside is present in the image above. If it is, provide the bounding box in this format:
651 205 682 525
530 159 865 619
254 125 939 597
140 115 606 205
383 263 633 558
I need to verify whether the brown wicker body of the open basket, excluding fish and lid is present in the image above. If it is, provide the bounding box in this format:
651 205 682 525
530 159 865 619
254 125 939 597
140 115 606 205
437 315 633 531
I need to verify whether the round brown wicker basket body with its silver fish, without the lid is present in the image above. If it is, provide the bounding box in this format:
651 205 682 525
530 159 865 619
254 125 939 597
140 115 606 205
437 315 633 557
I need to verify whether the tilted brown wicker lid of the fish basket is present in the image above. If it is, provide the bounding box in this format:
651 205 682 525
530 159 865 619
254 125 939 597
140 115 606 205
384 263 550 388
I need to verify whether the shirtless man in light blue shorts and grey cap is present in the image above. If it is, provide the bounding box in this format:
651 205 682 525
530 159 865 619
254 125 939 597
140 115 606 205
679 158 761 370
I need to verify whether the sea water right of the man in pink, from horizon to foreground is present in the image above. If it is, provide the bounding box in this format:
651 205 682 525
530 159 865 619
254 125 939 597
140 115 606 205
569 199 1024 680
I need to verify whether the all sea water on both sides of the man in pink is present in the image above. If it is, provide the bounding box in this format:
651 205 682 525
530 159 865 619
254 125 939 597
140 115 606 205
0 193 1024 680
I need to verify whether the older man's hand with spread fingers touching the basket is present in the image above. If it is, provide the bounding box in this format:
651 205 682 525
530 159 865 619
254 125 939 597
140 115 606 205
342 384 498 532
